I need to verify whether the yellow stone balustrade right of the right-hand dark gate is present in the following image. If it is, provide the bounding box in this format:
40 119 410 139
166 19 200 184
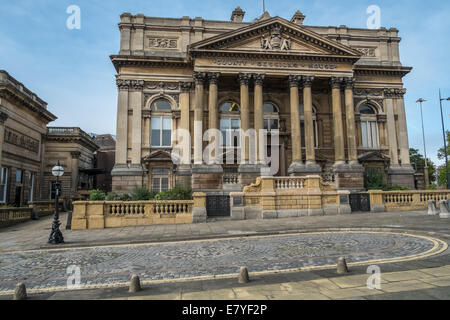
369 190 450 212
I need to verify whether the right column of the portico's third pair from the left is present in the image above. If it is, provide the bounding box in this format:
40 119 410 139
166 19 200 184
303 76 322 173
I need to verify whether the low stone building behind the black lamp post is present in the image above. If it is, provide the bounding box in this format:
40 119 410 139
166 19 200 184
41 127 99 199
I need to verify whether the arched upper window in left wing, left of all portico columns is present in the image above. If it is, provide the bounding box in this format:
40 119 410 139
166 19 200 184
150 99 172 147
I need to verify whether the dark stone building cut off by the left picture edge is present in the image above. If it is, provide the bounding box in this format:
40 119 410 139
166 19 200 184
0 70 56 207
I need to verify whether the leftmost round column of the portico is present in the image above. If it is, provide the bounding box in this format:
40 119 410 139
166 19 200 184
194 72 206 165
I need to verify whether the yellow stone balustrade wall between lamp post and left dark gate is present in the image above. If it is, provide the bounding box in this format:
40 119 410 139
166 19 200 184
72 193 206 230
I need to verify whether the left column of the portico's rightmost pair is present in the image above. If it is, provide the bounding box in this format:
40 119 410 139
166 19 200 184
331 77 345 167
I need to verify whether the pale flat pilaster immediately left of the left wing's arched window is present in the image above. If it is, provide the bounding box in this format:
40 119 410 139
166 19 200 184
130 80 144 169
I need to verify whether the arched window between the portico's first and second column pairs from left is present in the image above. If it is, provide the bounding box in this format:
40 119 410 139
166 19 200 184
219 101 241 148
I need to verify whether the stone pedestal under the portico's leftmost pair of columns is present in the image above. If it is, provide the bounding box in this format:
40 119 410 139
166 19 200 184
192 164 223 192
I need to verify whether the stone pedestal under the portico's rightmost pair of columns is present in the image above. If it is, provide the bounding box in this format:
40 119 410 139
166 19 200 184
331 162 365 192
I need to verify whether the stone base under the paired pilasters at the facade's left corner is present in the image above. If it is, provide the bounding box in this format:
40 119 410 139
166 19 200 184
111 164 144 191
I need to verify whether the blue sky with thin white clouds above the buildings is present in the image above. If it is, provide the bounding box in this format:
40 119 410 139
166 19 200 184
0 0 450 168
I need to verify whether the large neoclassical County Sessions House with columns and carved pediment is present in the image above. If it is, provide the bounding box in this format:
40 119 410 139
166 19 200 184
111 7 414 194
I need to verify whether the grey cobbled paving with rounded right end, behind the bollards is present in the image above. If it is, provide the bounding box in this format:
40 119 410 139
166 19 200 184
0 232 443 291
